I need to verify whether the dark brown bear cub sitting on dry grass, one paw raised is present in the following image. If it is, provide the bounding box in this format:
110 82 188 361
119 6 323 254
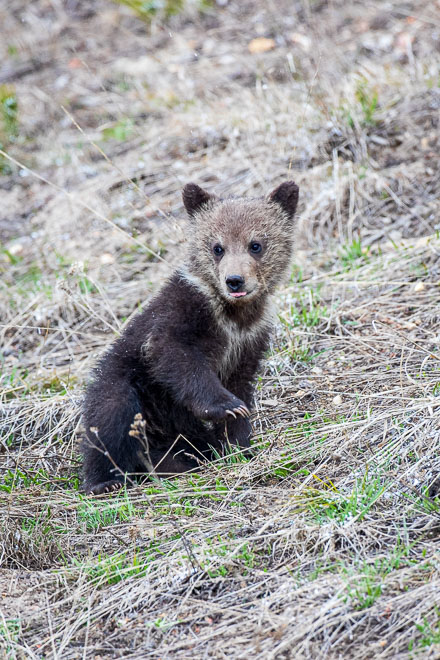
82 181 298 494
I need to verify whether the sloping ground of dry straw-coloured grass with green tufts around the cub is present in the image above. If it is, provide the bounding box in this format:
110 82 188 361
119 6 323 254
0 0 440 659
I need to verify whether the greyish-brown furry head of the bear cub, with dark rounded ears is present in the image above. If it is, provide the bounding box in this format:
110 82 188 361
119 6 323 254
183 181 298 305
